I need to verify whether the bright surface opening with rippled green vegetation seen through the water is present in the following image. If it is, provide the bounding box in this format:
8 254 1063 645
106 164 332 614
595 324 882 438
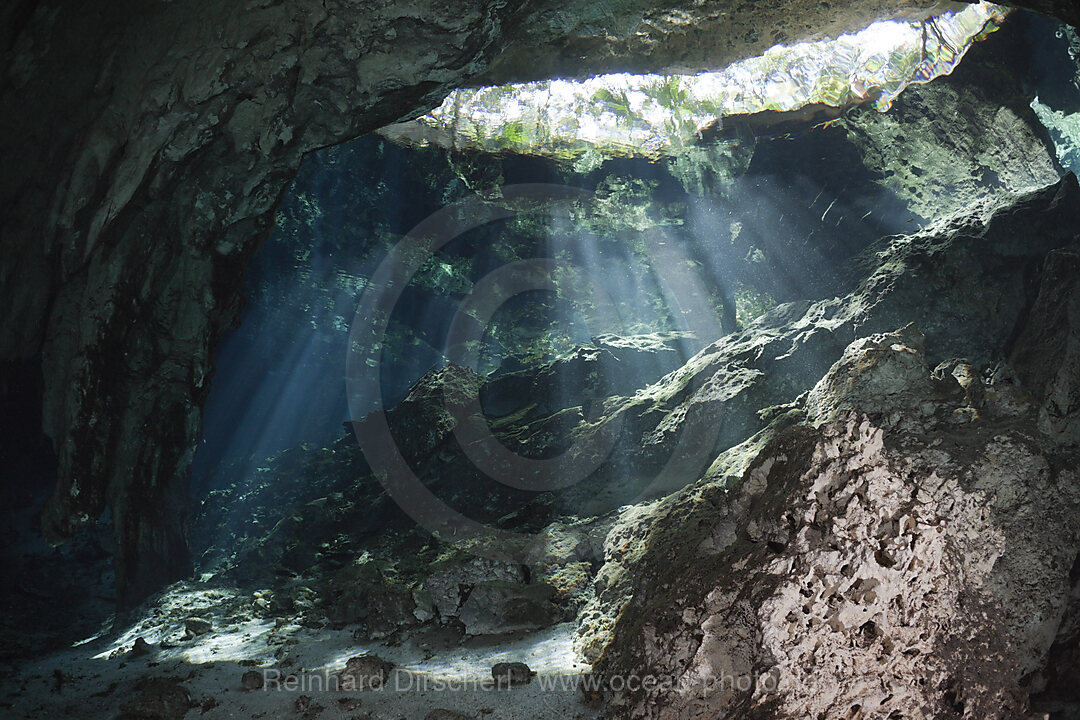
380 3 1008 165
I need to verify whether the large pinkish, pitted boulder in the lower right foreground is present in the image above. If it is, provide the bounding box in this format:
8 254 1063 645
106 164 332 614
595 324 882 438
582 327 1080 718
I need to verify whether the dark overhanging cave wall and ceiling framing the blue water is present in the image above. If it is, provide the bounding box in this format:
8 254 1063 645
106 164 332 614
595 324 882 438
0 0 1075 601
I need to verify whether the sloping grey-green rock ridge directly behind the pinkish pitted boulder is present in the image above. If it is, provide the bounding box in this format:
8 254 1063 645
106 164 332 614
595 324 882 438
580 175 1080 497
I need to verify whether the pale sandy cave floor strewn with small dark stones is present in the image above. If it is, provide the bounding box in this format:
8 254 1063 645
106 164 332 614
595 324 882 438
0 585 598 720
